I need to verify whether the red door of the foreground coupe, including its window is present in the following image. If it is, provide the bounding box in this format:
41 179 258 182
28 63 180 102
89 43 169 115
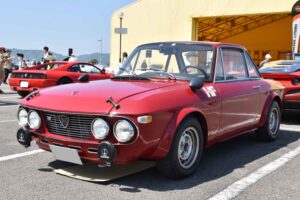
215 47 259 138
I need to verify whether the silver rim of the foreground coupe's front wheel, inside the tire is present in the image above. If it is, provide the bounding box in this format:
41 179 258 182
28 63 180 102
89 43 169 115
178 127 199 169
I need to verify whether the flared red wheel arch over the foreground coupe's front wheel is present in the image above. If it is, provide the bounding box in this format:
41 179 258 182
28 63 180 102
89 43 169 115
152 108 208 159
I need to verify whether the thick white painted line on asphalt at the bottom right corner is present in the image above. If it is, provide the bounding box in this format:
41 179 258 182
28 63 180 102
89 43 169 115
209 146 300 200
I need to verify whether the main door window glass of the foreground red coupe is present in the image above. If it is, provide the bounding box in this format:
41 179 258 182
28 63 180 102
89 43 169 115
222 48 248 80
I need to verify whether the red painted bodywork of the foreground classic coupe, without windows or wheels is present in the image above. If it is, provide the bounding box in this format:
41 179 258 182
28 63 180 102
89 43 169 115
16 43 283 164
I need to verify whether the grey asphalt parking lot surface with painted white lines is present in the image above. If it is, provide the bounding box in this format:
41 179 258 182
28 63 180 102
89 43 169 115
0 85 300 200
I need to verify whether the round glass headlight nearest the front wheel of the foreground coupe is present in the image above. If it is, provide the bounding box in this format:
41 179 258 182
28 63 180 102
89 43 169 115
114 120 134 142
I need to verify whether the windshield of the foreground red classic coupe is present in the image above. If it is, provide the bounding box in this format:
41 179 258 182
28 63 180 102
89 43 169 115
117 43 214 80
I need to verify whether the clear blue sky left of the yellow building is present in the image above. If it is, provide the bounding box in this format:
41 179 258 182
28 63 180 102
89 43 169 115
0 0 134 55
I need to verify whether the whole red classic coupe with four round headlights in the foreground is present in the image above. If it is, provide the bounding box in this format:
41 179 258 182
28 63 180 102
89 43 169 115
17 42 284 178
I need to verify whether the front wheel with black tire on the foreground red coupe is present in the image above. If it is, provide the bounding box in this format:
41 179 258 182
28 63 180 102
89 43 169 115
157 117 204 179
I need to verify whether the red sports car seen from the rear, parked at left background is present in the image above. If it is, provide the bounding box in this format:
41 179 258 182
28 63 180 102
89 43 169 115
8 62 112 97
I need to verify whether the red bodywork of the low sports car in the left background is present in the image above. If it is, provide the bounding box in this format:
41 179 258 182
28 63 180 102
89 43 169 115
8 62 113 92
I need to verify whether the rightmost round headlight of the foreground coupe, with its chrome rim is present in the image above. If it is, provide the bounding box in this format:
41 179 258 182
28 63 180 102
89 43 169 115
114 119 136 143
